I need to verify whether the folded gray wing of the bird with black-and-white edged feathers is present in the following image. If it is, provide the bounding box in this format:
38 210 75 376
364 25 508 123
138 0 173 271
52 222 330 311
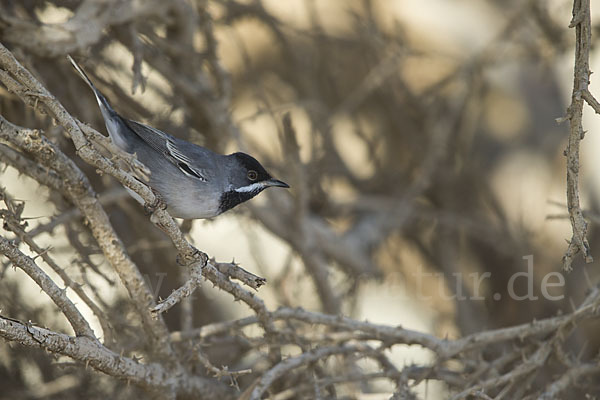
123 118 207 182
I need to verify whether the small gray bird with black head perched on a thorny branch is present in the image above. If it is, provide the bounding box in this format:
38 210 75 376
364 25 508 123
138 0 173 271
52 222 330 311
68 56 289 219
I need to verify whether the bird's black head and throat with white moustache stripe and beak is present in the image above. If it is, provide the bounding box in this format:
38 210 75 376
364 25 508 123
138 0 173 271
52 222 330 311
219 153 289 213
